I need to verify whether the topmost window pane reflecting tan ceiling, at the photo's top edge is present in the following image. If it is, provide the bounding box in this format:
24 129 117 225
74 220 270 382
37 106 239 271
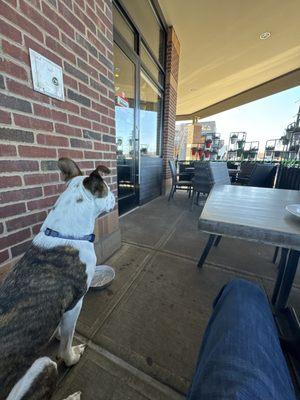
123 0 165 64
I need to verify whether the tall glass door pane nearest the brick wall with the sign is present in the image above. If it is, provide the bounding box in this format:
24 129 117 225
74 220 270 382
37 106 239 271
114 43 138 214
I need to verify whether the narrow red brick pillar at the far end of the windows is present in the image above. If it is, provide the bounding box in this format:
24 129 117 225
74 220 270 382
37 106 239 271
163 27 180 186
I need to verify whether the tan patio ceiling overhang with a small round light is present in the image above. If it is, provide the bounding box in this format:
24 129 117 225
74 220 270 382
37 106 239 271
159 0 300 119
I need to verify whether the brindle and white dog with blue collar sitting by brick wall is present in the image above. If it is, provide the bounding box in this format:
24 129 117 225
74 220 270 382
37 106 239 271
0 158 115 400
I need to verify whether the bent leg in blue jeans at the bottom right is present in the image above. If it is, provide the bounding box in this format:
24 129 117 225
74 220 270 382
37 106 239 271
187 279 296 400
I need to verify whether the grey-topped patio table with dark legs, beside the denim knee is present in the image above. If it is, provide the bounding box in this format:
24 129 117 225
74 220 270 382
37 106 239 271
198 185 300 368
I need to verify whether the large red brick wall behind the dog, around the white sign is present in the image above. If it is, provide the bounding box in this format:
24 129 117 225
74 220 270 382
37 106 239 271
0 0 116 267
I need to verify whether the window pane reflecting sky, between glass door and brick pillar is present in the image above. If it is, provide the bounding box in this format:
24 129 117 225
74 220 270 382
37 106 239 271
140 72 162 156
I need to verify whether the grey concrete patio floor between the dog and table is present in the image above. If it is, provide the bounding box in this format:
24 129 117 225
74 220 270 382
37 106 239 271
54 193 300 400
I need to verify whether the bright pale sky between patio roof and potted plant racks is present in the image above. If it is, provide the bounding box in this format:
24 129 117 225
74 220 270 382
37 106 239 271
177 86 300 152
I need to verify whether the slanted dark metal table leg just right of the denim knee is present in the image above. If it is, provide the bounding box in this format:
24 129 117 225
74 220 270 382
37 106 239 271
272 250 300 311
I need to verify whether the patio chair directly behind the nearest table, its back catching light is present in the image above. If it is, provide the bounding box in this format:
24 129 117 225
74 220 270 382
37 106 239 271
191 161 231 209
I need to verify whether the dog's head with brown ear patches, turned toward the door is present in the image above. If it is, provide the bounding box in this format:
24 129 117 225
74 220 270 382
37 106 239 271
58 158 115 215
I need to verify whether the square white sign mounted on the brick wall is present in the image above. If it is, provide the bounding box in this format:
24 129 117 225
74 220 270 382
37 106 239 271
29 49 65 101
